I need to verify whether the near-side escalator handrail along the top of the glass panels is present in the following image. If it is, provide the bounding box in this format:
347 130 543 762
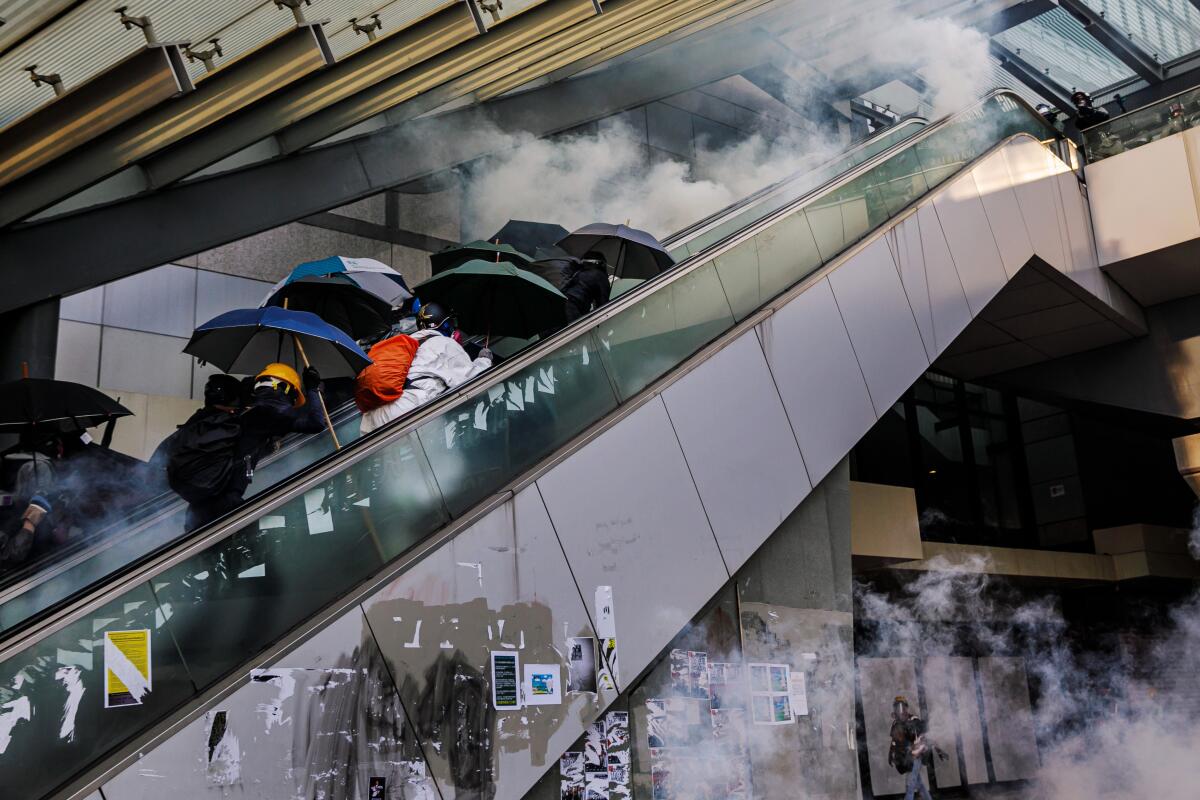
0 89 1058 662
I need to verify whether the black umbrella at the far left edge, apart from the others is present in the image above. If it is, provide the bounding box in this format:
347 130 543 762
0 378 133 433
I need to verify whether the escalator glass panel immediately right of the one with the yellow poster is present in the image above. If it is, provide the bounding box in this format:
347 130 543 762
154 434 448 687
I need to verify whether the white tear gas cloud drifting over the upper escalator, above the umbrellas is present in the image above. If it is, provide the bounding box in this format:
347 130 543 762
463 10 991 239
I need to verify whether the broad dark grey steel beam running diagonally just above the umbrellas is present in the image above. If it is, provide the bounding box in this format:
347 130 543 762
0 18 779 312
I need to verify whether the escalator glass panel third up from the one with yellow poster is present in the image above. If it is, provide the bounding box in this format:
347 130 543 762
599 261 733 399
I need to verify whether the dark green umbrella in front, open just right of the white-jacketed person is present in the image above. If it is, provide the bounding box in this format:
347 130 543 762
414 259 566 338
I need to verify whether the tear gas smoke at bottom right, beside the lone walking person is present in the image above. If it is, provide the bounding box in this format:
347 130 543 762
856 559 1200 800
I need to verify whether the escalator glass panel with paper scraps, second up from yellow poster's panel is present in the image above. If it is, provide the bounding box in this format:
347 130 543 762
419 333 617 515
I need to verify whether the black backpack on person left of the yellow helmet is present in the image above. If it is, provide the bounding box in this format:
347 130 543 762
167 409 241 503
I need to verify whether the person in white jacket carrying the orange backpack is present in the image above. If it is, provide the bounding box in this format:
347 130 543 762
360 302 492 434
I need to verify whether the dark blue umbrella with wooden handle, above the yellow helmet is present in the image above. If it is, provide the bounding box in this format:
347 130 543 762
184 306 371 378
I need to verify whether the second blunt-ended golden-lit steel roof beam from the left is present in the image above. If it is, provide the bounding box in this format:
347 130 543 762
0 23 331 227
